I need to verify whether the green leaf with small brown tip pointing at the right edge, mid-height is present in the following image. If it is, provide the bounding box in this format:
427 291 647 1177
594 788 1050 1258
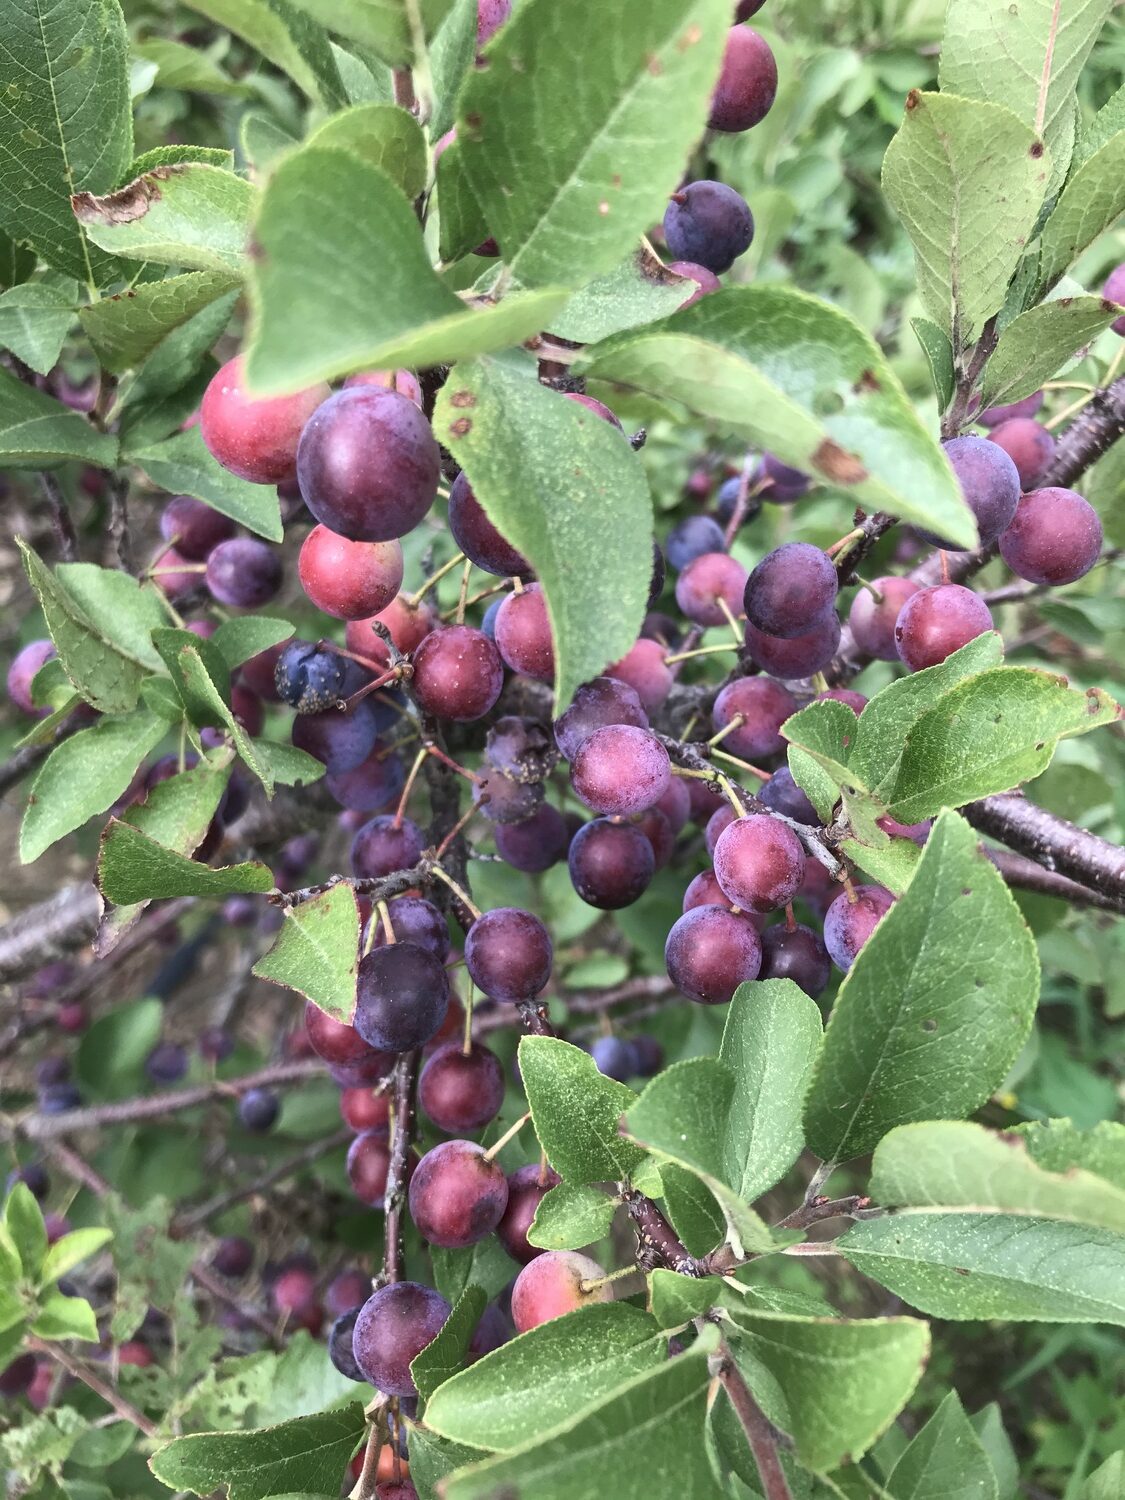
888 666 1121 824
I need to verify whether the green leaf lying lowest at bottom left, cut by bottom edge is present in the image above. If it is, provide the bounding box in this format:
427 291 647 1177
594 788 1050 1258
149 1401 365 1500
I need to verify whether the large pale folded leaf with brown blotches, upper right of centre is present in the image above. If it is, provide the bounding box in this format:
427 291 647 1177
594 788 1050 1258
575 285 977 546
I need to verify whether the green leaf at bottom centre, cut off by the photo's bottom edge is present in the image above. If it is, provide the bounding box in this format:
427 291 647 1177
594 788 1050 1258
444 1350 714 1500
